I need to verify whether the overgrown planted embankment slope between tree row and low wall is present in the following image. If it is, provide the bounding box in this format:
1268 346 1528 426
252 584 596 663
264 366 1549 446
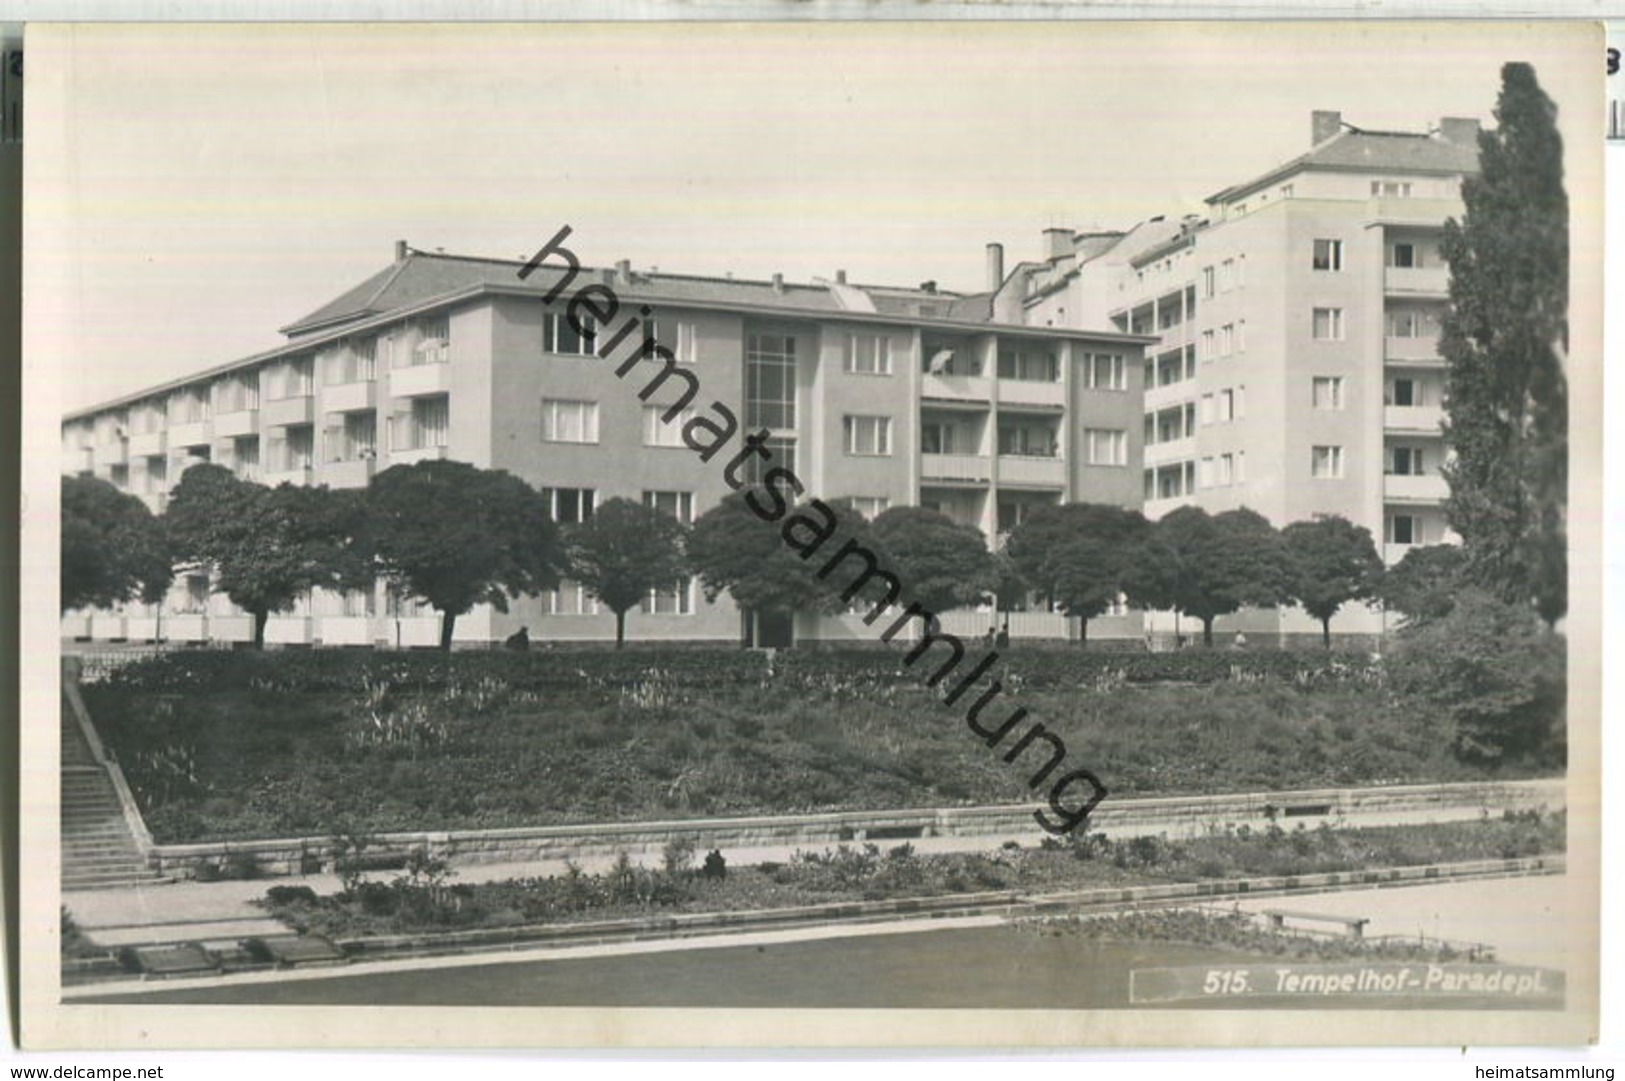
86 650 1562 842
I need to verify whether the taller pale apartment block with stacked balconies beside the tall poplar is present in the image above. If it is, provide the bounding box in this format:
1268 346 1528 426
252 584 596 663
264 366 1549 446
995 112 1479 634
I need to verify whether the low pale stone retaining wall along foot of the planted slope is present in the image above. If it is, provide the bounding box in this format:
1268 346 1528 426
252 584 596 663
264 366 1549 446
150 779 1567 876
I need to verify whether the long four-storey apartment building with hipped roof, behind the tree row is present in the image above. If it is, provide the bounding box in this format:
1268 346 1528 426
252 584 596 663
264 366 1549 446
62 244 1147 647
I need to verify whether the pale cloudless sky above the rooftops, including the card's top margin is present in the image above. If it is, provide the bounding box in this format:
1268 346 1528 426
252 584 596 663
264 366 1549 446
24 23 1602 410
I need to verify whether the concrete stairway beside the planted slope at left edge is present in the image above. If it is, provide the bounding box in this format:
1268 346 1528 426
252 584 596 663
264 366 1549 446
62 702 158 891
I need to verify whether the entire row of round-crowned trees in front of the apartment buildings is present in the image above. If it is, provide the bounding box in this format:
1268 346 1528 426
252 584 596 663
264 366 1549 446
62 451 1459 649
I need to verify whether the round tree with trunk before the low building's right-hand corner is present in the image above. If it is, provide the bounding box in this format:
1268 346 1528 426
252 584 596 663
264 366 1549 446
1006 502 1151 647
